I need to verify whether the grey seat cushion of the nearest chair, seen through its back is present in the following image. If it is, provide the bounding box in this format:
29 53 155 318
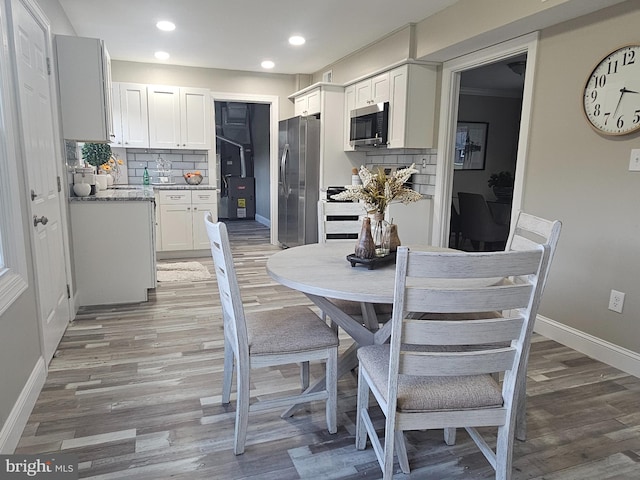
358 344 503 412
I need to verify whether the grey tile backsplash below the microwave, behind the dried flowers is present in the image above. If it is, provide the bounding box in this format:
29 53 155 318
365 148 437 196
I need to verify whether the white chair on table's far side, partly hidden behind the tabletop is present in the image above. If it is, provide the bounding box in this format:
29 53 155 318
318 200 391 330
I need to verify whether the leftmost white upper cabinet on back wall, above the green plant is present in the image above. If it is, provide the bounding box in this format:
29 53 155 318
111 82 149 148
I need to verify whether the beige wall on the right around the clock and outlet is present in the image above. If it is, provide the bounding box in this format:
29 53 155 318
524 0 640 352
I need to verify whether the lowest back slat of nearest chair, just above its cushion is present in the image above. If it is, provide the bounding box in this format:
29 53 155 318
398 347 516 377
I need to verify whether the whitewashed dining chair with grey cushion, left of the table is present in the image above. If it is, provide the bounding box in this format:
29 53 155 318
204 213 338 455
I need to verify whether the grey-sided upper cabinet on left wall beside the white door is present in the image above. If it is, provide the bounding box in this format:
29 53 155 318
55 35 113 143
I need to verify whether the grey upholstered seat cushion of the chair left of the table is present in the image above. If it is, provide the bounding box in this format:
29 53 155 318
245 307 338 355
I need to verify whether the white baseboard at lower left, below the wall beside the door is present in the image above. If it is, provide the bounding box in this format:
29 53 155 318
0 357 47 455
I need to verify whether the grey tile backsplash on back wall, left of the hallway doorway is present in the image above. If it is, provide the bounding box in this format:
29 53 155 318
126 148 209 185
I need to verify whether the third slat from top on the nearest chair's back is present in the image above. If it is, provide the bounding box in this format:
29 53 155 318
402 317 524 345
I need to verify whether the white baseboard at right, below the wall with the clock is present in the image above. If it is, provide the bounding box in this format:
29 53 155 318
534 315 640 378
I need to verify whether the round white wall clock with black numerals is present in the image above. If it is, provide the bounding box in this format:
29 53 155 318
583 45 640 135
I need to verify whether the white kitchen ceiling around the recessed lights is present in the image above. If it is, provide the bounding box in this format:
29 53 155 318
59 0 457 74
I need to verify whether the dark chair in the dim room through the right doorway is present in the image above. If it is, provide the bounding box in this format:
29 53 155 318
458 192 509 250
